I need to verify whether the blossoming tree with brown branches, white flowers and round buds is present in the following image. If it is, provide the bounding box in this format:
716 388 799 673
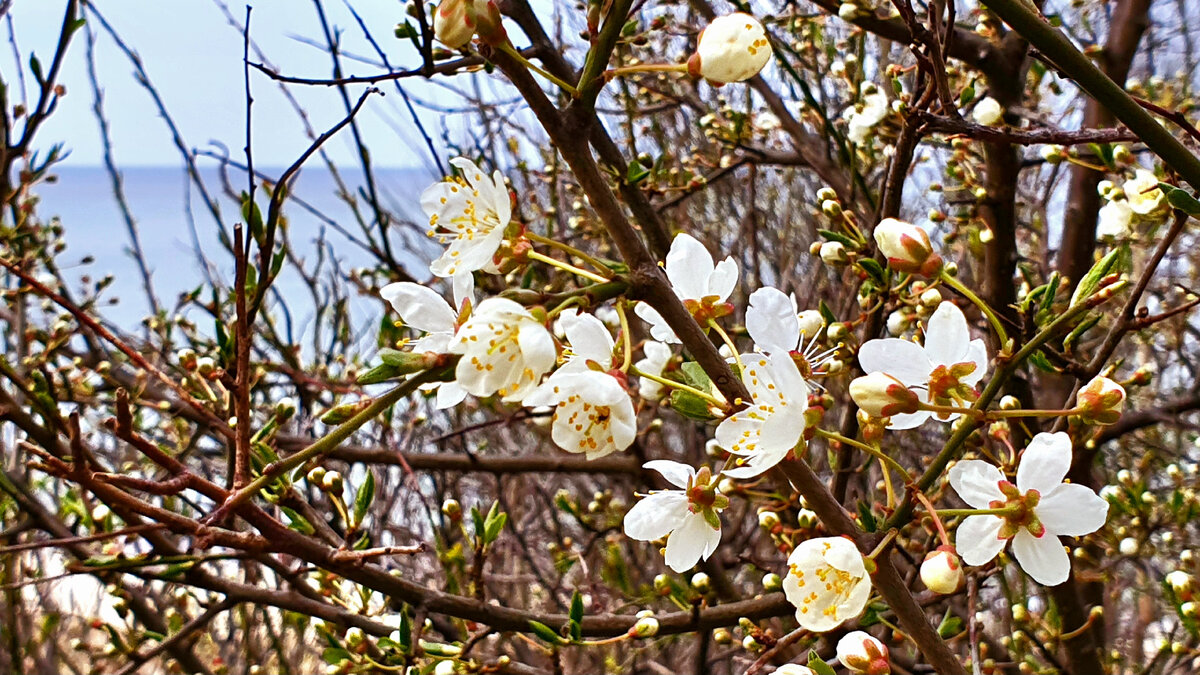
0 0 1200 675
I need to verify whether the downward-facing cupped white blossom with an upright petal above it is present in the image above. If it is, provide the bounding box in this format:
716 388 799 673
523 311 637 459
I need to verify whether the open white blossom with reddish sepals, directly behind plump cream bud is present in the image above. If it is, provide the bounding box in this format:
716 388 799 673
858 301 988 429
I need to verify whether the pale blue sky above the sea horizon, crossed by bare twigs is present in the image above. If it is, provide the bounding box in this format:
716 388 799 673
0 0 445 167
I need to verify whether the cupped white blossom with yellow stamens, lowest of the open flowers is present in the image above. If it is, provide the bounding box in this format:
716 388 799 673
784 537 871 633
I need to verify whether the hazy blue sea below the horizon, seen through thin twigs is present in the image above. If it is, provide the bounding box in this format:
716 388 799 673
37 167 437 328
